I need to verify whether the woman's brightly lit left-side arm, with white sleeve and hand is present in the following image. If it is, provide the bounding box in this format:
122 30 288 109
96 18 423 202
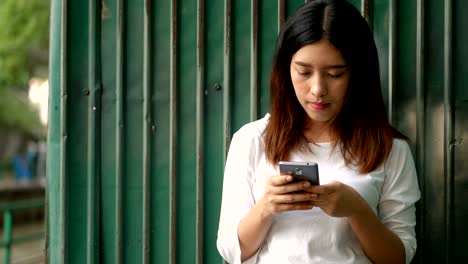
216 129 312 264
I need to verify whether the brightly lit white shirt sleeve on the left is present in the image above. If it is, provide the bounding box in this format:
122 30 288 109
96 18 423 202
216 130 257 264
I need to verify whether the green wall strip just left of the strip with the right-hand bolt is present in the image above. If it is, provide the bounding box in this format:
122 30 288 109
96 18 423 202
176 0 197 263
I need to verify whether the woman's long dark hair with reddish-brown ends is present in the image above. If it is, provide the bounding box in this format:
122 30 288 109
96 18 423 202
264 0 406 173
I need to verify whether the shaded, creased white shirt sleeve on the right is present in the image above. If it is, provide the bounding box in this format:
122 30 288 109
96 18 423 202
379 140 421 263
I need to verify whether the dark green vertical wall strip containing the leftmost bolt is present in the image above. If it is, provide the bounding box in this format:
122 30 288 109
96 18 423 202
67 1 94 263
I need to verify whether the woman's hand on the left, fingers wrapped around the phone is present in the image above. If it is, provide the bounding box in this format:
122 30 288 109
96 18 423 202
260 175 317 217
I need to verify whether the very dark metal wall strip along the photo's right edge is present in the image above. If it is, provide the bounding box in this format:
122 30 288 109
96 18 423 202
450 0 468 263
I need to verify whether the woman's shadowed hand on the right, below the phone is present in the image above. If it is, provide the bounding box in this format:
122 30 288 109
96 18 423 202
307 181 368 217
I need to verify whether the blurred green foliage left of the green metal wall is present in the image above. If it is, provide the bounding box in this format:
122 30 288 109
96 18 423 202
0 0 50 139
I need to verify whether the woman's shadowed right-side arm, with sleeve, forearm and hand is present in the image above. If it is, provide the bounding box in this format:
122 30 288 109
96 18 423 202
308 140 420 263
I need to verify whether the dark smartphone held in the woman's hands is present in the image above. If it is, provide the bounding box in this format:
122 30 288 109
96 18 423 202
279 161 320 185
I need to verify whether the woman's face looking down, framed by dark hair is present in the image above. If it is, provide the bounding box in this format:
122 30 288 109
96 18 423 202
291 39 350 124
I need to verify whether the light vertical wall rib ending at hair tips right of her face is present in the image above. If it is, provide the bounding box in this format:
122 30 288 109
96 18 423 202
388 0 397 124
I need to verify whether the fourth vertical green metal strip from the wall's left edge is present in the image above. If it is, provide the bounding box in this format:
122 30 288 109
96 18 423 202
122 1 145 263
